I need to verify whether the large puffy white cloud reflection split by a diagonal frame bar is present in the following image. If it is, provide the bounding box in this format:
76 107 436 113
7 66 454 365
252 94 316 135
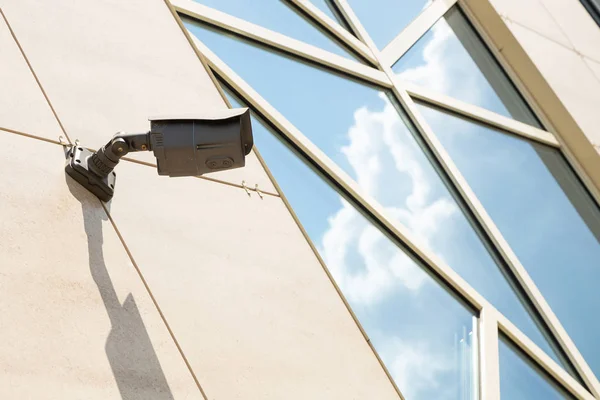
321 95 458 305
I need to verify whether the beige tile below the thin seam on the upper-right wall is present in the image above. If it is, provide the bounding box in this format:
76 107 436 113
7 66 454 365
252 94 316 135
507 18 600 147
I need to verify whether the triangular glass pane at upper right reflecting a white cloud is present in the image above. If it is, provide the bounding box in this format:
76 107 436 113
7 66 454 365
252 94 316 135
392 7 539 127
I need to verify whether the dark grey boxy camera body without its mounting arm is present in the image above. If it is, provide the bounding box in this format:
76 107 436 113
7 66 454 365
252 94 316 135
150 108 253 177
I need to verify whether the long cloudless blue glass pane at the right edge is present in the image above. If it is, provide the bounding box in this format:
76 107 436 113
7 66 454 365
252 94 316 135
418 102 600 375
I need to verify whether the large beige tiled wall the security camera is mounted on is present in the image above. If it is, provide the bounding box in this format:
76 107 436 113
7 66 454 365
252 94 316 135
0 0 398 399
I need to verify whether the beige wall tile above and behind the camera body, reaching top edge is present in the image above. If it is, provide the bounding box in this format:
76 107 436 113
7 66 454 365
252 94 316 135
0 0 275 192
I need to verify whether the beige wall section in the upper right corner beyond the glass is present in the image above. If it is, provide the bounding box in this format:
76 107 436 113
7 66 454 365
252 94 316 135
491 0 600 151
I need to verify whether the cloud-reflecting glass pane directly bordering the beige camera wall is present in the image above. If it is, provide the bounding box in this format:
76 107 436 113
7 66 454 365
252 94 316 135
226 92 477 400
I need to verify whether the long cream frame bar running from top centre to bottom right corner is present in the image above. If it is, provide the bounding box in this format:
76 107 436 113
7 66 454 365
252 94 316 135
335 0 600 397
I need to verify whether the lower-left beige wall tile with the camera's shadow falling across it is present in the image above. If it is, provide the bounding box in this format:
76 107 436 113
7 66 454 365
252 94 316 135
0 132 202 400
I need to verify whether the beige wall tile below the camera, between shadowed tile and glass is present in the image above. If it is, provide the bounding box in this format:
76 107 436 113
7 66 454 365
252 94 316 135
110 159 398 400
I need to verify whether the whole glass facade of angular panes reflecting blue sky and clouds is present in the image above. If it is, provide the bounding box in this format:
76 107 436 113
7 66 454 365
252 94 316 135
181 0 600 400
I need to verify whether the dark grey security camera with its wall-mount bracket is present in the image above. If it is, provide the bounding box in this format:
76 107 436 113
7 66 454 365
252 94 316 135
65 108 253 201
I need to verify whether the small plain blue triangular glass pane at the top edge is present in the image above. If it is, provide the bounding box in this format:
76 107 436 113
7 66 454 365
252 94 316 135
348 0 431 50
